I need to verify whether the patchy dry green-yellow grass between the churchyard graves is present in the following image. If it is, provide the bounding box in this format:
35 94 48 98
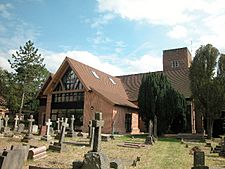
0 136 225 169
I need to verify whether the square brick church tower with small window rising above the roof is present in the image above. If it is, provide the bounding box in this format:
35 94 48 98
163 47 192 71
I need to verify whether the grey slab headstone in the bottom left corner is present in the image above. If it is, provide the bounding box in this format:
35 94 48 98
0 147 25 169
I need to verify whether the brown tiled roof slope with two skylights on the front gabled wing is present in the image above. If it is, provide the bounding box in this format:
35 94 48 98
66 57 137 108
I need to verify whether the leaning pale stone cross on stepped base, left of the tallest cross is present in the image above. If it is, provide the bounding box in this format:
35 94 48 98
49 118 68 153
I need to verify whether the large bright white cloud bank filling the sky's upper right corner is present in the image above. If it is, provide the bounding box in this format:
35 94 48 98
98 0 225 51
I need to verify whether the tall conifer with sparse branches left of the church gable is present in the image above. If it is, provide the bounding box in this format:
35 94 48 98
8 40 48 116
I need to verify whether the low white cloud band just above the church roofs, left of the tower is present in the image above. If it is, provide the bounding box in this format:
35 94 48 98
41 50 162 76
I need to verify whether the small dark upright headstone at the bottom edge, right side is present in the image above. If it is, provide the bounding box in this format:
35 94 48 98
192 151 209 169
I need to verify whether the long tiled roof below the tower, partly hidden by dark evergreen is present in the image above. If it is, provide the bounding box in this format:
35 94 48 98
118 69 191 101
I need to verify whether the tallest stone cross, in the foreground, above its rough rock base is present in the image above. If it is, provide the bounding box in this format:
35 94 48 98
92 112 104 152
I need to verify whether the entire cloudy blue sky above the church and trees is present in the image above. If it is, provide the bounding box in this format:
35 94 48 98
0 0 225 75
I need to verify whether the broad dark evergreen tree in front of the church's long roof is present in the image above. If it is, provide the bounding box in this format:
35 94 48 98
138 73 186 134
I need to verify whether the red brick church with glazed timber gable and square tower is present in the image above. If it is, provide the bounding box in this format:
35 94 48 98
38 48 198 134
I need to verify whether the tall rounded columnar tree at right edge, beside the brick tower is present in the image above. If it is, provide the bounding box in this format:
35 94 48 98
190 44 225 138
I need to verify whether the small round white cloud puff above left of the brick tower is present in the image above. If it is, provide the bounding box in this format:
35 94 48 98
168 25 188 39
